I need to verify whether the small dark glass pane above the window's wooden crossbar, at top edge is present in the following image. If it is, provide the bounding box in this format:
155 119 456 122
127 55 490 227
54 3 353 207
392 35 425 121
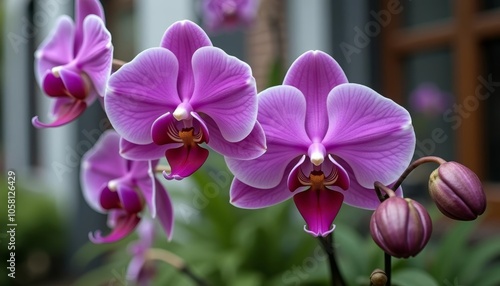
402 0 452 27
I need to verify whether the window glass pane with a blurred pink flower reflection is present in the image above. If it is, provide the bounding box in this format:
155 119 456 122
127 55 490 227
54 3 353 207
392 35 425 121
404 49 455 196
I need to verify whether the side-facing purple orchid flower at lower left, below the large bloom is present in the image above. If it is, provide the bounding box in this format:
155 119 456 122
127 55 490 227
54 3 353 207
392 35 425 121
80 130 173 243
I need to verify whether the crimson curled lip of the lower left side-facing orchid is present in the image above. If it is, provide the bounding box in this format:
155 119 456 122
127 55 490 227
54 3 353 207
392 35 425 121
89 212 141 244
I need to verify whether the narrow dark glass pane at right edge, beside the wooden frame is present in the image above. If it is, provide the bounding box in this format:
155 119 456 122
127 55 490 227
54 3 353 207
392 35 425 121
478 39 500 182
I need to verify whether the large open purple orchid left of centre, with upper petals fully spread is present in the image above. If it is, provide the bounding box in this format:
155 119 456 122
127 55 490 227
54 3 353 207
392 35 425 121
105 21 265 179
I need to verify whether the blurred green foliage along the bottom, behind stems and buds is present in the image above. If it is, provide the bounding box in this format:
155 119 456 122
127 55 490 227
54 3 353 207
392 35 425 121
75 153 500 286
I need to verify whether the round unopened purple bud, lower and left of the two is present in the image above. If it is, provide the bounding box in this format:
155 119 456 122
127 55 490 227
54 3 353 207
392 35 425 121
370 197 432 258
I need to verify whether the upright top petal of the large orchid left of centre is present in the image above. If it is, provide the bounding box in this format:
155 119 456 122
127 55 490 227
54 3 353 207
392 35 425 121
161 20 212 100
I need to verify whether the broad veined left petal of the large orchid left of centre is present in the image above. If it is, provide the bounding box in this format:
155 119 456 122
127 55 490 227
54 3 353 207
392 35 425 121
104 48 180 144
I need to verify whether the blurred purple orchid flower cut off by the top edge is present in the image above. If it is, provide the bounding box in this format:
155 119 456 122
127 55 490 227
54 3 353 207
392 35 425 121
202 0 259 31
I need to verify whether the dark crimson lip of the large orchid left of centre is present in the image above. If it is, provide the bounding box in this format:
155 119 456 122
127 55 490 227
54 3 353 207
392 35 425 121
163 143 208 180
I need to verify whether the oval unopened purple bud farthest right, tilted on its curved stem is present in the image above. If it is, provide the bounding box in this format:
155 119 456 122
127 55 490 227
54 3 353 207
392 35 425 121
429 162 486 220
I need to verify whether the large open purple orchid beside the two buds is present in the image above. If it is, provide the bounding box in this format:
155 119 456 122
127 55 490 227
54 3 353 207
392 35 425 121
226 51 415 236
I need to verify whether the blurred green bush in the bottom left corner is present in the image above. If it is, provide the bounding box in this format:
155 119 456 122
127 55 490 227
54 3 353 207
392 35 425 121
0 177 67 285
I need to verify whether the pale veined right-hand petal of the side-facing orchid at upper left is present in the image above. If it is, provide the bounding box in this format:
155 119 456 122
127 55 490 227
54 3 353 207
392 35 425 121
75 15 113 96
